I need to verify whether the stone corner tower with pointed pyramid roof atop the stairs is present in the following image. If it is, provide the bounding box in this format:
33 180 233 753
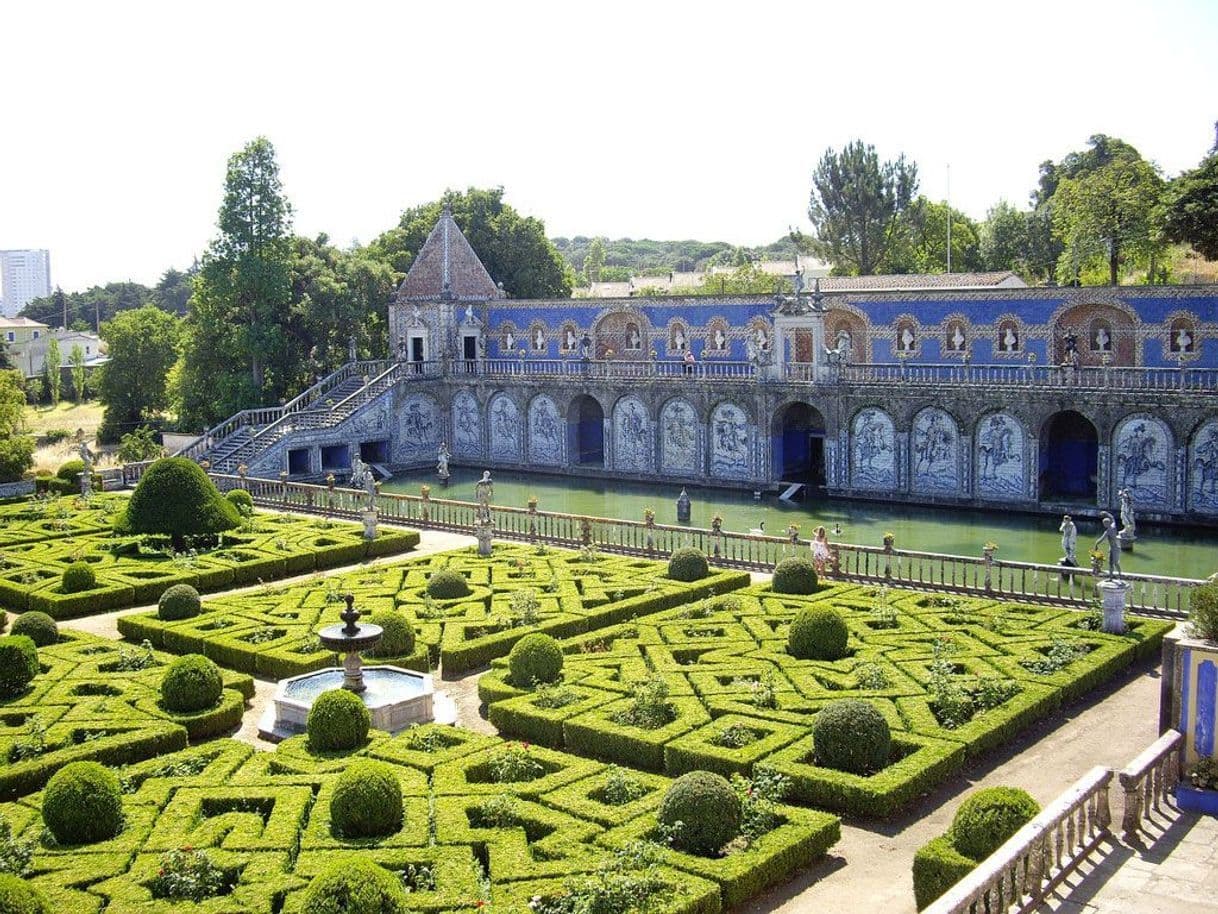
389 205 504 362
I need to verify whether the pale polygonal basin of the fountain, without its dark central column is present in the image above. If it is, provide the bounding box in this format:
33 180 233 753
258 667 436 740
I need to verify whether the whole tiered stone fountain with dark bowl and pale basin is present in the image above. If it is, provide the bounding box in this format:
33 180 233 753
258 593 457 742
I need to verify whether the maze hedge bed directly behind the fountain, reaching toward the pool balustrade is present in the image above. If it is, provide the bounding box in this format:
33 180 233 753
118 544 749 679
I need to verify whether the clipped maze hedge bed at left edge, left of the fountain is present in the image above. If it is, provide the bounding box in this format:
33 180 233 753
0 629 253 797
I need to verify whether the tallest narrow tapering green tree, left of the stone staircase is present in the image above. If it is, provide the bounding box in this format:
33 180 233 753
179 136 292 422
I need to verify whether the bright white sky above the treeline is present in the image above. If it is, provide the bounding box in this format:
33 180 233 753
0 0 1218 290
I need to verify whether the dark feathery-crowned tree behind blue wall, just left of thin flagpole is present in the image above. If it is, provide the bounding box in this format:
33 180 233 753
808 140 917 275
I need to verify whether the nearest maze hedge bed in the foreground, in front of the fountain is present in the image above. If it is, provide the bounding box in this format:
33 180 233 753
0 725 838 914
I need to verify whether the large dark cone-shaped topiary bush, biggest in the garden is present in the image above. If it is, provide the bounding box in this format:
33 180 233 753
114 457 241 550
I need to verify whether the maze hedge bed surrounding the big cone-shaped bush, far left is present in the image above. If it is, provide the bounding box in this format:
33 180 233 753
0 496 419 619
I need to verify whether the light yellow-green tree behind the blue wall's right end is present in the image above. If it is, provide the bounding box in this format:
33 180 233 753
1051 155 1163 285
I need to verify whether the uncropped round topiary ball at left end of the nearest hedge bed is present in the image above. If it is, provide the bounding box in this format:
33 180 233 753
43 762 123 845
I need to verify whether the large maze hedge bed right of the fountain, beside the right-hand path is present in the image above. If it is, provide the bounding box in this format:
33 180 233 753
479 584 1170 817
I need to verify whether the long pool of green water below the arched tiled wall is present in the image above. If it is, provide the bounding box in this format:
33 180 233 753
382 468 1218 578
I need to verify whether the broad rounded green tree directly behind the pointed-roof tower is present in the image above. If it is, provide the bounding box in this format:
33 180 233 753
368 188 574 299
